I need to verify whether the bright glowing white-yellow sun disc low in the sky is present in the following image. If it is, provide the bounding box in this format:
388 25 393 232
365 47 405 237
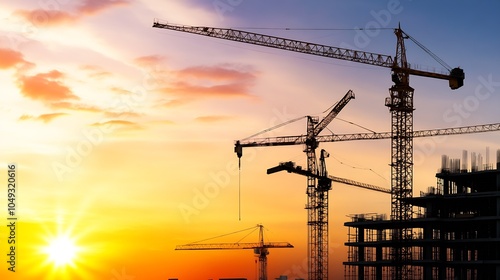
44 235 78 266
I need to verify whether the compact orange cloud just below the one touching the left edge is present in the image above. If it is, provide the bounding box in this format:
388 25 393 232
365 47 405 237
19 70 79 102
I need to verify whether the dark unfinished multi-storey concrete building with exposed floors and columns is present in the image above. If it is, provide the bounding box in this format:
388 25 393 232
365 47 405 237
344 149 500 280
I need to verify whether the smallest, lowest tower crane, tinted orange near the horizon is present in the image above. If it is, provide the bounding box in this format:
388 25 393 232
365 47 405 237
175 225 293 280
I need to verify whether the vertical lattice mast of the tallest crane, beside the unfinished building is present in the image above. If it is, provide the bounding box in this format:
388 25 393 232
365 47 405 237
385 25 414 279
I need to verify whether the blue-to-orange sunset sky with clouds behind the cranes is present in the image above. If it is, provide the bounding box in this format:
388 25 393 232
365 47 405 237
0 0 500 280
